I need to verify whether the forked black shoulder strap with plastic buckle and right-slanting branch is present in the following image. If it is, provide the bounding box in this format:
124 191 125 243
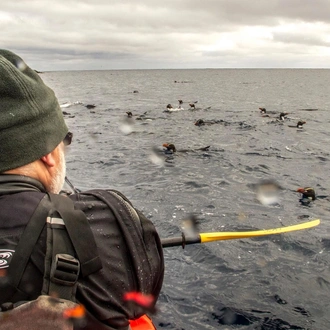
42 194 102 301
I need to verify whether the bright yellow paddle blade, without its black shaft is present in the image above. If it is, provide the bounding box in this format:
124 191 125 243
199 219 320 243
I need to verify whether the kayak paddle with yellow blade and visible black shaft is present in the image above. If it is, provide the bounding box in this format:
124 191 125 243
161 219 320 248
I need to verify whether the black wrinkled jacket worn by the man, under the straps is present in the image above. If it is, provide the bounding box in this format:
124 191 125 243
0 175 164 328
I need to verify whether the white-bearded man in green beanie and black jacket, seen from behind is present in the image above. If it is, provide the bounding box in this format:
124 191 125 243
0 49 164 330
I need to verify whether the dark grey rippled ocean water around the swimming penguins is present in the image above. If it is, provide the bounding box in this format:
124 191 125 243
41 69 330 330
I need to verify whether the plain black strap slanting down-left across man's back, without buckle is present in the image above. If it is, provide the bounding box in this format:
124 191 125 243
1 195 50 301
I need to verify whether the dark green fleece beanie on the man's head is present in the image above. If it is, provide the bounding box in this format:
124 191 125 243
0 49 68 173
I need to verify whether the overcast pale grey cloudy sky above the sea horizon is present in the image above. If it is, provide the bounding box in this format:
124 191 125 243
0 0 330 71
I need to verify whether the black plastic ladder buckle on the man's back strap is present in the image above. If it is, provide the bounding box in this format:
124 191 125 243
50 253 80 286
